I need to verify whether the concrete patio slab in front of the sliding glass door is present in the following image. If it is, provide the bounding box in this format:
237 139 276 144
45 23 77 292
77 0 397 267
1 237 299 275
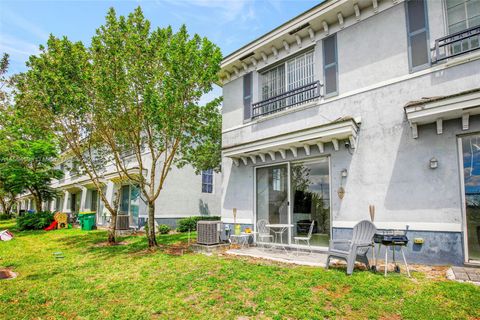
226 247 327 267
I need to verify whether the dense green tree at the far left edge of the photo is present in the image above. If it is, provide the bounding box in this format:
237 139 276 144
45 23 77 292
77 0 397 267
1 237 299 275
0 54 62 213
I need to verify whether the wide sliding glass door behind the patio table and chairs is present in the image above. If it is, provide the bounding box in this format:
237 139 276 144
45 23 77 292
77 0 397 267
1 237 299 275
256 158 331 247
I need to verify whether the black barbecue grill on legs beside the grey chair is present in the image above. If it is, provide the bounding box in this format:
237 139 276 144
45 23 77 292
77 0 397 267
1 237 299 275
372 230 410 276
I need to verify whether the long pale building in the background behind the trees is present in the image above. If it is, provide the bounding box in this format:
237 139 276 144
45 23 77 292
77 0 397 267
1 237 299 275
17 153 221 230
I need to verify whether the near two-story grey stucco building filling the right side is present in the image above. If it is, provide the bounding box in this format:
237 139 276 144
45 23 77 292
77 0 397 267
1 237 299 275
220 0 480 264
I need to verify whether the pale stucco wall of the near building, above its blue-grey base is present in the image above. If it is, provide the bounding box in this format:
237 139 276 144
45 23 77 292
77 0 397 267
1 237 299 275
222 1 480 231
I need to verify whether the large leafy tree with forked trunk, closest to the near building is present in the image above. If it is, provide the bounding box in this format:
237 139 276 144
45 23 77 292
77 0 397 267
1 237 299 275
91 8 222 246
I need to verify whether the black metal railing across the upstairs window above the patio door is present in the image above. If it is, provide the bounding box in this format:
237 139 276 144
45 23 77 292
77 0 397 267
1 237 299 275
252 81 321 119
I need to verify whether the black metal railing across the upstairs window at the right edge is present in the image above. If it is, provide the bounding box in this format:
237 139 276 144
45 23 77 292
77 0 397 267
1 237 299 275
432 25 480 63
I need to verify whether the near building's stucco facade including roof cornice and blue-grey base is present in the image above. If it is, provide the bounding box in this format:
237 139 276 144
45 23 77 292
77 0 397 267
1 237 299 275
221 1 480 265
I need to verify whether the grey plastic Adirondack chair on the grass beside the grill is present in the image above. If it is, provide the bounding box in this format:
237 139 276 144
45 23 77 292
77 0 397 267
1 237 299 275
325 220 377 275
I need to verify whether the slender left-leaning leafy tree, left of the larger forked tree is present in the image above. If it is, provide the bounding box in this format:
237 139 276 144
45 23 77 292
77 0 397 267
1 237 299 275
16 36 119 243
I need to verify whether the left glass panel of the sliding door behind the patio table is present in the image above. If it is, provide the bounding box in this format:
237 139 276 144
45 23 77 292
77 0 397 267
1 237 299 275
256 164 289 243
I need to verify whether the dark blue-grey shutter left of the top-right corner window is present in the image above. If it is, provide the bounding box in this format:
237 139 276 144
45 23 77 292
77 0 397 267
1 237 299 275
406 0 430 71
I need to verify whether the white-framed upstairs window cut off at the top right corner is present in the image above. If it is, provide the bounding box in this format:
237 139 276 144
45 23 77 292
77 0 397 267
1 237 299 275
445 0 480 54
